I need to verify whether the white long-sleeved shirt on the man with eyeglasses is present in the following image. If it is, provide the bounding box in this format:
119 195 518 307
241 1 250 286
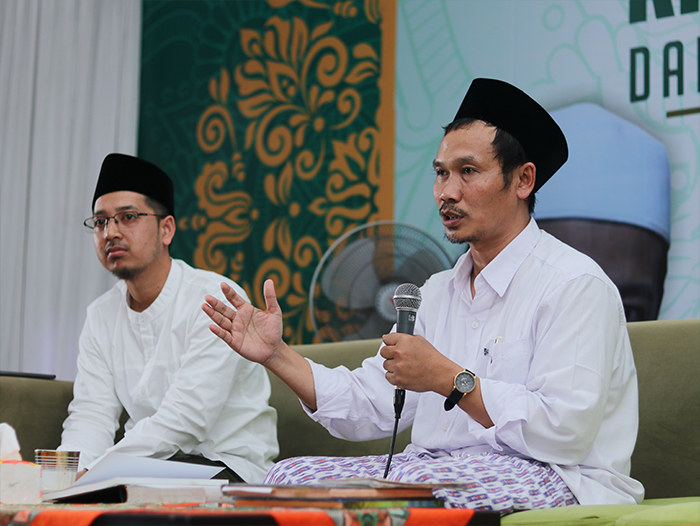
61 260 279 483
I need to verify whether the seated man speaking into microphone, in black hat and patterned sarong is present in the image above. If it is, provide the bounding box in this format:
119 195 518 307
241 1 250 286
202 79 643 513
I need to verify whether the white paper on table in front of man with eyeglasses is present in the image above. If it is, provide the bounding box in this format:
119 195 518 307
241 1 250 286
70 453 224 488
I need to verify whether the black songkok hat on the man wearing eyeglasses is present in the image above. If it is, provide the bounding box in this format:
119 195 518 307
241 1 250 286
92 153 175 216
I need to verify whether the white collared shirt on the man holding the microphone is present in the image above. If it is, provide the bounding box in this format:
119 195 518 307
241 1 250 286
307 219 644 504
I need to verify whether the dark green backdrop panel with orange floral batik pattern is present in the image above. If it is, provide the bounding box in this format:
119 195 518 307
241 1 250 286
138 0 395 343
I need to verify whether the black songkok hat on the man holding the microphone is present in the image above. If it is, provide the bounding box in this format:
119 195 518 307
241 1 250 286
455 79 569 193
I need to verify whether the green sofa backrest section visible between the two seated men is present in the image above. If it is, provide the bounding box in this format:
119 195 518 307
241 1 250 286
269 339 411 460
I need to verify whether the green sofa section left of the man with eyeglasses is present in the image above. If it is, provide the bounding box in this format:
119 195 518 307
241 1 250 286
0 376 73 462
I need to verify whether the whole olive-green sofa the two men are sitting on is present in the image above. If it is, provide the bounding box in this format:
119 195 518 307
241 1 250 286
0 319 700 526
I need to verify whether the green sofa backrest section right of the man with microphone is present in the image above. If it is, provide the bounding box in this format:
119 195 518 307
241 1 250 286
627 319 700 498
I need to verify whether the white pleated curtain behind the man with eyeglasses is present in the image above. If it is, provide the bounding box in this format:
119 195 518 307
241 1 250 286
0 0 141 380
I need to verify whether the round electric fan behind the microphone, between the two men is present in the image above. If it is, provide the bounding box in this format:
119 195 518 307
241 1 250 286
309 221 454 342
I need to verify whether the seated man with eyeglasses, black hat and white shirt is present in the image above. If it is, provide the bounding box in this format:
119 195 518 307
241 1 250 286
60 154 279 483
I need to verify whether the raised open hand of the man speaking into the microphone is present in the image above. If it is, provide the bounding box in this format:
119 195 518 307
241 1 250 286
202 279 282 365
